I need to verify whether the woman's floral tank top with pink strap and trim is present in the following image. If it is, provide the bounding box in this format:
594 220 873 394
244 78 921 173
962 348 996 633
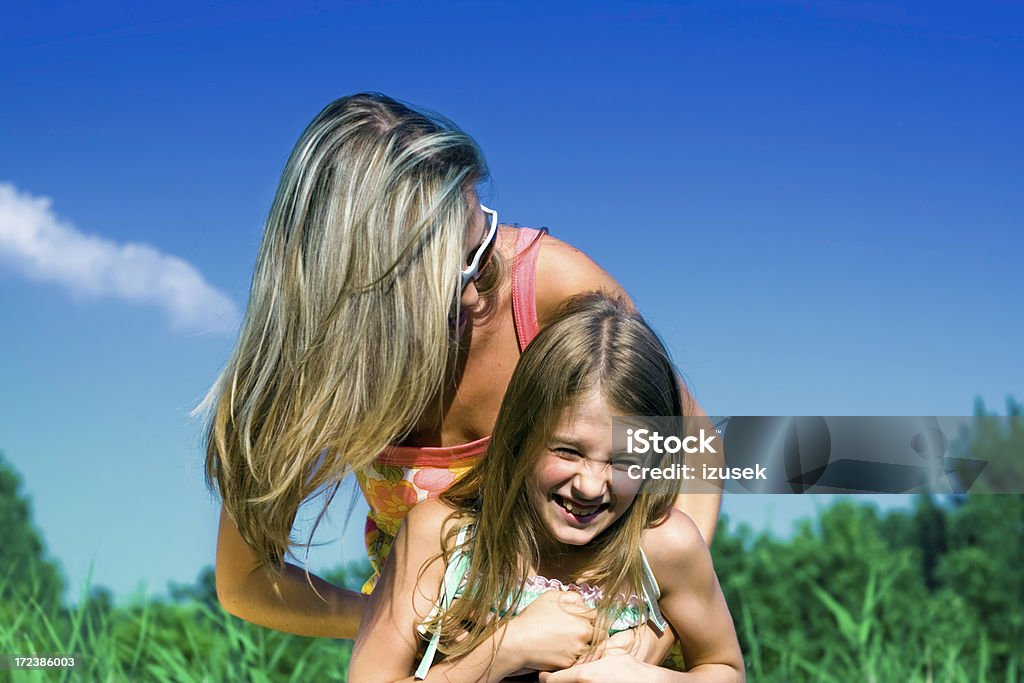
355 227 547 593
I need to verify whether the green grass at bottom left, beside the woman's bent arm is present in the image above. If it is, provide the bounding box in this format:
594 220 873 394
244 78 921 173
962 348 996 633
0 573 351 683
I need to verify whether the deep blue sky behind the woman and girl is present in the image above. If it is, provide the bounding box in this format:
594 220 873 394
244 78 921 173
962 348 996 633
0 1 1024 596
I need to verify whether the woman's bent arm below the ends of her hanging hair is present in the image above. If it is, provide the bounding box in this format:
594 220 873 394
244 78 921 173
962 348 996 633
215 510 367 638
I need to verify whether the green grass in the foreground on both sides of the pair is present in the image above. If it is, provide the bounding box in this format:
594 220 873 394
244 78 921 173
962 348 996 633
6 572 1019 683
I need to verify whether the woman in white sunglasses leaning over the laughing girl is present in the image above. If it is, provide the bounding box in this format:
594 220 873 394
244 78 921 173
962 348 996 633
206 93 720 638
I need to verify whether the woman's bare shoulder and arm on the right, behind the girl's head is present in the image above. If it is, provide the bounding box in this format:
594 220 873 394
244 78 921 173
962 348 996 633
537 236 725 544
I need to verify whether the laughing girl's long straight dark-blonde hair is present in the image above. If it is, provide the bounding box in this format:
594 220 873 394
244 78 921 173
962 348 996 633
429 294 685 656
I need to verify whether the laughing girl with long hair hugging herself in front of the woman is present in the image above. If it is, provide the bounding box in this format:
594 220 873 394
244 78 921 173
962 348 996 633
349 295 743 683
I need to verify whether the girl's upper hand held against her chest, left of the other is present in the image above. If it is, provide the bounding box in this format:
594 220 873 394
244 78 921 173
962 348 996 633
500 591 596 671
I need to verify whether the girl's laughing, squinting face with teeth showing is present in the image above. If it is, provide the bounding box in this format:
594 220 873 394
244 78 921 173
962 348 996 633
528 389 641 546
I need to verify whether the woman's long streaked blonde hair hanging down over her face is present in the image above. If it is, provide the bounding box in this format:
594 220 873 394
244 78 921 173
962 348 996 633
206 93 486 567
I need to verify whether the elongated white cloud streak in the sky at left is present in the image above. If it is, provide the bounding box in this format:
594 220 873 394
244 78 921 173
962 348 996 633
0 182 239 334
